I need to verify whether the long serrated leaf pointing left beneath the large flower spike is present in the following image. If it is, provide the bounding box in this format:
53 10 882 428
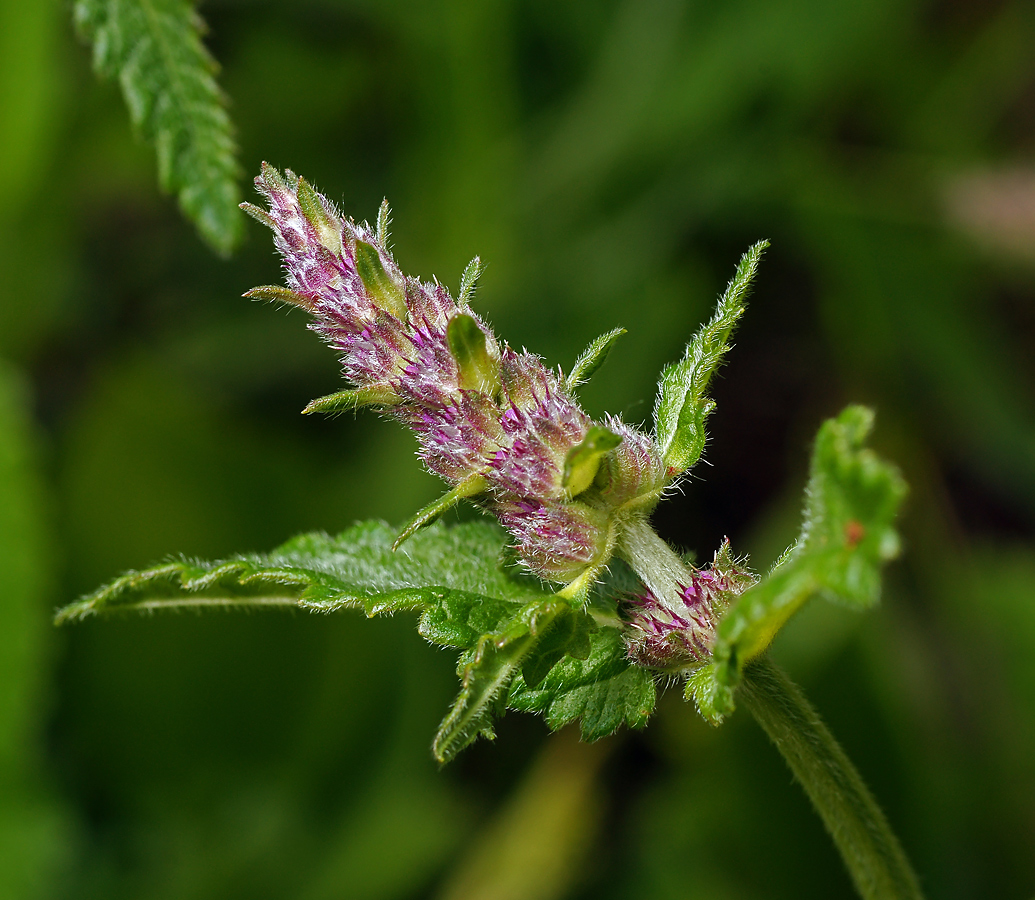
57 521 550 628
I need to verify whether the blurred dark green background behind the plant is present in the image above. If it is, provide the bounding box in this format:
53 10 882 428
0 0 1035 900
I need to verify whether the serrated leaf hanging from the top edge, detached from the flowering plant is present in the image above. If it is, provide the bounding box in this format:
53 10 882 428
75 0 242 253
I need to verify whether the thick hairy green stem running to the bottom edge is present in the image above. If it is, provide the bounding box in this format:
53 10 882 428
737 656 923 900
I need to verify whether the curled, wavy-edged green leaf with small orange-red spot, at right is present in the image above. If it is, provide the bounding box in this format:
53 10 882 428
688 407 906 719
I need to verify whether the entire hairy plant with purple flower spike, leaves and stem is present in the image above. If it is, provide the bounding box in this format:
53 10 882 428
58 164 920 898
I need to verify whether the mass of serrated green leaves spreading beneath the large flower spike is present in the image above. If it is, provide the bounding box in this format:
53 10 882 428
57 521 654 762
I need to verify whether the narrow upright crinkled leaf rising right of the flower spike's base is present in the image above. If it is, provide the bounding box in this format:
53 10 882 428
654 241 769 475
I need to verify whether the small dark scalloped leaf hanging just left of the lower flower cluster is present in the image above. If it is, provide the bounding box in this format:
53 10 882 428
507 626 656 741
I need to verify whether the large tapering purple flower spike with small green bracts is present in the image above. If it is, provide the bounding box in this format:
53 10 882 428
245 166 667 582
